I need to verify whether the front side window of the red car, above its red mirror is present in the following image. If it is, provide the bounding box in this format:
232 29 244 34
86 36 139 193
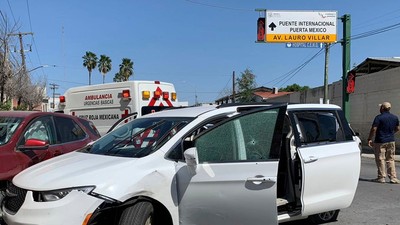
19 116 55 145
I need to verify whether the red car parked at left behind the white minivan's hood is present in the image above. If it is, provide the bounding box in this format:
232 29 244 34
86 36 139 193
0 111 100 191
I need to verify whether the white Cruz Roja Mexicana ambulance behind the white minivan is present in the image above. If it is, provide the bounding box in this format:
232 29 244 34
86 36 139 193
59 81 182 135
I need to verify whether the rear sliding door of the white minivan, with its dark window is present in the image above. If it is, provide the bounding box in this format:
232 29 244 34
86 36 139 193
289 110 361 216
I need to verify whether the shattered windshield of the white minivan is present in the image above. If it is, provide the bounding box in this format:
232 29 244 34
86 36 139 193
81 117 193 158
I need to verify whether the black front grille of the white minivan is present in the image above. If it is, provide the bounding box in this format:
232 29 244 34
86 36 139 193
4 182 26 214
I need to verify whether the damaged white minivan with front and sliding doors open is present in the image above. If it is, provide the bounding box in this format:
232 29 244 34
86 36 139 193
2 104 360 225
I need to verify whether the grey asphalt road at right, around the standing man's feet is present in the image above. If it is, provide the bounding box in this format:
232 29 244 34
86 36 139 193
282 158 400 225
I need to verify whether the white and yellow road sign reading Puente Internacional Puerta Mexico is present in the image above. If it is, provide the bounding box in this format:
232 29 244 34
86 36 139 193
265 10 337 43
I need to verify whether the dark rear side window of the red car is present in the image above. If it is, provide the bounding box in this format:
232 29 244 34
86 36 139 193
54 116 86 143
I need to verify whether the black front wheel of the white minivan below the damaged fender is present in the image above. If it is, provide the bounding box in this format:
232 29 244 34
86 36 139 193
118 202 154 225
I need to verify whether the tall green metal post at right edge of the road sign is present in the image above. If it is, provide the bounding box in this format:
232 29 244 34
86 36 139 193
341 14 351 122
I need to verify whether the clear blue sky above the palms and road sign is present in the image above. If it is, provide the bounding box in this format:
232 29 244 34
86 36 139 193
0 0 400 104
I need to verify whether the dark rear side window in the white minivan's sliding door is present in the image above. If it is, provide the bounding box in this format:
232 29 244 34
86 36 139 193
294 111 345 144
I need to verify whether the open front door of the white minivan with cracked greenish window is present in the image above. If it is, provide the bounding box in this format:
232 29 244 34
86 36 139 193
176 104 286 225
